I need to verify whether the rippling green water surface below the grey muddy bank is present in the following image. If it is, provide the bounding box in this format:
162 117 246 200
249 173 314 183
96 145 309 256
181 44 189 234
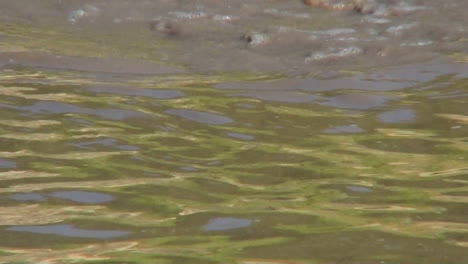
0 19 468 264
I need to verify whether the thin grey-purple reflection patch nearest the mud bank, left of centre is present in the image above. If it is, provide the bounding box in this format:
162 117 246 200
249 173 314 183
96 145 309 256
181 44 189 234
86 86 185 99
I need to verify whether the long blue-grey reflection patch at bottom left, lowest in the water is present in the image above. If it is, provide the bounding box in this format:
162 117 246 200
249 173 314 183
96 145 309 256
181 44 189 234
6 224 130 239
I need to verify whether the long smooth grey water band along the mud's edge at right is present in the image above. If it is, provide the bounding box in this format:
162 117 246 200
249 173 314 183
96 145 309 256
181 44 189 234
215 60 468 96
